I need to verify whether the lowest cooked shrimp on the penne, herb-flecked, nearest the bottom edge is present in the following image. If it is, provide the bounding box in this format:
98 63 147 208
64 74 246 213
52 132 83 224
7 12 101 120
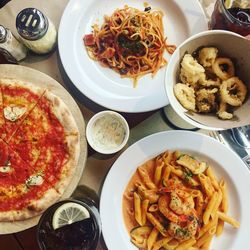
167 215 199 241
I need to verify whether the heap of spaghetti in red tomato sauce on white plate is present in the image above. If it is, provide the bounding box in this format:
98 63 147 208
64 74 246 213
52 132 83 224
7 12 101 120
83 6 176 84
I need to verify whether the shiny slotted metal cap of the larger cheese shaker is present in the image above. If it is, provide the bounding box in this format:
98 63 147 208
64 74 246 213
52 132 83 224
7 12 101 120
16 8 49 40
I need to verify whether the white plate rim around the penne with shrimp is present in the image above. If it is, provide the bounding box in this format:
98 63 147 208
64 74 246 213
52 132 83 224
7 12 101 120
100 131 250 250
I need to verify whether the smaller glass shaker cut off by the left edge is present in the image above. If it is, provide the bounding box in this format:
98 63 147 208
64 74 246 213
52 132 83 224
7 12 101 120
0 25 27 63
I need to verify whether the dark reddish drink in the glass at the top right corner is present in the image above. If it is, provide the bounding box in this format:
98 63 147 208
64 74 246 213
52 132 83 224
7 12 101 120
210 0 250 36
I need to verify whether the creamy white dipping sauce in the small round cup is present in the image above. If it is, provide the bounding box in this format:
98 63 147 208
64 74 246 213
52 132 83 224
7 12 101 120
91 114 126 150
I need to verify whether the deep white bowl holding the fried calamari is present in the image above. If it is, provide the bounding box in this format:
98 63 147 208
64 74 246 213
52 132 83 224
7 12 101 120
165 30 250 130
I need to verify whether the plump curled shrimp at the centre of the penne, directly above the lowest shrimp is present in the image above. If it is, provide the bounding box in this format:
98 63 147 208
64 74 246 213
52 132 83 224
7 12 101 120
169 189 194 215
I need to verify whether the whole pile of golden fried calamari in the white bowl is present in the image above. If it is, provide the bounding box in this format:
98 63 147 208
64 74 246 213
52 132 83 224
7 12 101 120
174 47 248 120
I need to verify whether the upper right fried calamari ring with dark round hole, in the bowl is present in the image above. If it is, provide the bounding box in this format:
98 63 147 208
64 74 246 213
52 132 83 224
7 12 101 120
212 57 235 80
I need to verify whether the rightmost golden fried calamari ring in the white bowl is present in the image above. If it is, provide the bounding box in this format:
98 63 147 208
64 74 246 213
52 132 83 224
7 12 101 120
220 77 247 107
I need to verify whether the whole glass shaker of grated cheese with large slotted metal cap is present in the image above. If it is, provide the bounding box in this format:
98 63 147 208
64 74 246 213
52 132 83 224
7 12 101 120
16 8 57 54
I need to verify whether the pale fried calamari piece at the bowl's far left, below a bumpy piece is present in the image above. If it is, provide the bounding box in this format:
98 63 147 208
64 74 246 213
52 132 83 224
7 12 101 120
174 83 196 111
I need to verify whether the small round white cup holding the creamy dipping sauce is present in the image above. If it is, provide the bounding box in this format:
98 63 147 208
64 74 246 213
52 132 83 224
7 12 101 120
86 110 129 154
